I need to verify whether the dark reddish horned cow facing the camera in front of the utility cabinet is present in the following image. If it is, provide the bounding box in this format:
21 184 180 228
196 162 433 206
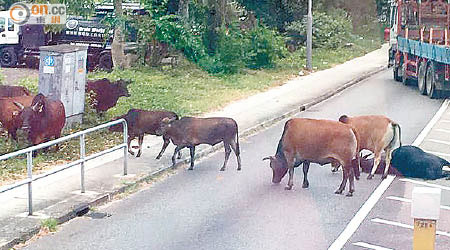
14 94 66 153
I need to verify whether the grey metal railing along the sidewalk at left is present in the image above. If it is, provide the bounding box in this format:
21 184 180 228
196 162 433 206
0 119 128 215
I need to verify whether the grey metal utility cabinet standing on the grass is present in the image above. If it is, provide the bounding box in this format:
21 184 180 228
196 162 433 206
39 44 87 126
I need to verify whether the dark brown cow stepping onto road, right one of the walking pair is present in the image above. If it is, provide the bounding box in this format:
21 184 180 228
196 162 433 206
157 117 241 171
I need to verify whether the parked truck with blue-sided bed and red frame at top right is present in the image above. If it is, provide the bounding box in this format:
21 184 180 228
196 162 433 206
389 0 450 98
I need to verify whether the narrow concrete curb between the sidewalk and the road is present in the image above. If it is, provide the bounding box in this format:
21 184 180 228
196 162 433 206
1 66 387 250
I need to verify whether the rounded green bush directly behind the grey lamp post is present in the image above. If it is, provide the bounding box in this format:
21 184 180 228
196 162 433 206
286 11 352 48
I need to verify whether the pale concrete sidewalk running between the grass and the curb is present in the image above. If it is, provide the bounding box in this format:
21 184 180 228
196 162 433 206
0 45 388 249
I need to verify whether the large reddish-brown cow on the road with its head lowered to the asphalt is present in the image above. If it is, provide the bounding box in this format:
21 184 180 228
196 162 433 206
263 118 359 196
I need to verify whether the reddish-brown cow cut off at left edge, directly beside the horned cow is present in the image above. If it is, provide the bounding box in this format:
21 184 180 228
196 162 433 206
0 96 33 141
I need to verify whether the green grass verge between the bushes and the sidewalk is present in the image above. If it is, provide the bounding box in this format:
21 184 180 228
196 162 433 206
0 36 380 185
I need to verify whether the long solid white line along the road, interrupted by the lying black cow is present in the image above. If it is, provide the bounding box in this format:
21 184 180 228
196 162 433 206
328 99 450 250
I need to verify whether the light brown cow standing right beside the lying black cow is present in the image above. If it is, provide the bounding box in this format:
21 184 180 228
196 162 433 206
339 115 402 179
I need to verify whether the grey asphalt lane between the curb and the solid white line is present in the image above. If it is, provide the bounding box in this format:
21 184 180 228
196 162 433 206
22 71 442 250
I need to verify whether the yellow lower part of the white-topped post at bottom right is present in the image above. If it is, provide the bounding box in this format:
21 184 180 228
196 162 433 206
413 219 436 250
